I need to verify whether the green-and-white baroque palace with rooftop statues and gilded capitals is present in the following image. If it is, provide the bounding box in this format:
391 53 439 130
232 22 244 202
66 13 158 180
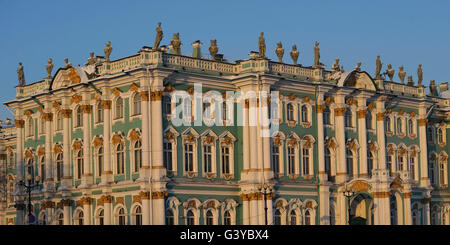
0 32 450 225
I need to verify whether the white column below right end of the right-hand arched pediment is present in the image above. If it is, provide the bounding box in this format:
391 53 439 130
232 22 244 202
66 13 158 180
376 100 386 169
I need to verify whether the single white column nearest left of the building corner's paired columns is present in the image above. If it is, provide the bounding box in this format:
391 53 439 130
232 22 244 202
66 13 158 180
101 99 113 185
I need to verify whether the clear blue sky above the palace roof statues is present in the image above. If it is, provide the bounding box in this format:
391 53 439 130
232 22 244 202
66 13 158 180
0 0 450 119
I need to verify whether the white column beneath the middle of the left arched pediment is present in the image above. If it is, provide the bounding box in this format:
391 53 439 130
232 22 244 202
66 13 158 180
62 109 72 189
